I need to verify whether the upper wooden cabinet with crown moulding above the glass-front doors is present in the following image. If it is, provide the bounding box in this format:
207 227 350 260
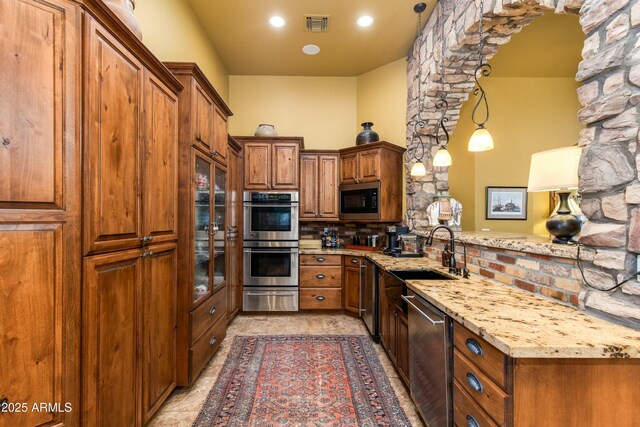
165 62 233 166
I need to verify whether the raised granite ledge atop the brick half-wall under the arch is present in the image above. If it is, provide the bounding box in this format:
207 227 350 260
415 230 578 259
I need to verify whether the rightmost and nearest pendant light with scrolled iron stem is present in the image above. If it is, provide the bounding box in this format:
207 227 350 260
469 0 493 152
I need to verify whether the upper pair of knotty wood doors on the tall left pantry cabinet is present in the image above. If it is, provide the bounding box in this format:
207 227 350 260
84 16 178 254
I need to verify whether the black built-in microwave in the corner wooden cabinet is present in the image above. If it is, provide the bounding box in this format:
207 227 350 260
340 181 380 220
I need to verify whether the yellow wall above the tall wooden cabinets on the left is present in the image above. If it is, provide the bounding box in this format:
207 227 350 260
135 0 229 103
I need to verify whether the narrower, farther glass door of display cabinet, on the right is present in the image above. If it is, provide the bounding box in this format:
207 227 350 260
212 165 227 292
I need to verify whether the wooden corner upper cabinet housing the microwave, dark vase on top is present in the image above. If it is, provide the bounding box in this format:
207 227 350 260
340 141 406 222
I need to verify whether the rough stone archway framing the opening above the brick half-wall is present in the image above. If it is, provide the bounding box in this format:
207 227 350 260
406 0 640 320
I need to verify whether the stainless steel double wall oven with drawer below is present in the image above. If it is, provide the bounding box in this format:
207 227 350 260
243 191 299 311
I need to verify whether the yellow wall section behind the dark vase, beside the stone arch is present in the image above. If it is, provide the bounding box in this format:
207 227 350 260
356 58 407 147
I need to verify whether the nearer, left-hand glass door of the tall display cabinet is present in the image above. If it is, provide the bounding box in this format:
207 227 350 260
193 150 214 306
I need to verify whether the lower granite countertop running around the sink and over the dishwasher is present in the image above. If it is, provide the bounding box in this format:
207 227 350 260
300 249 640 359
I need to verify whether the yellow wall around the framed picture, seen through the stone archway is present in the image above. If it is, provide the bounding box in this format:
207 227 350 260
449 77 582 235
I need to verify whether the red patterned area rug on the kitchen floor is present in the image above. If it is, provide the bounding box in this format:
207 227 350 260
193 335 411 427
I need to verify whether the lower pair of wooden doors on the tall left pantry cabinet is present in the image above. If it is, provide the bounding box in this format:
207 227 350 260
82 243 177 425
